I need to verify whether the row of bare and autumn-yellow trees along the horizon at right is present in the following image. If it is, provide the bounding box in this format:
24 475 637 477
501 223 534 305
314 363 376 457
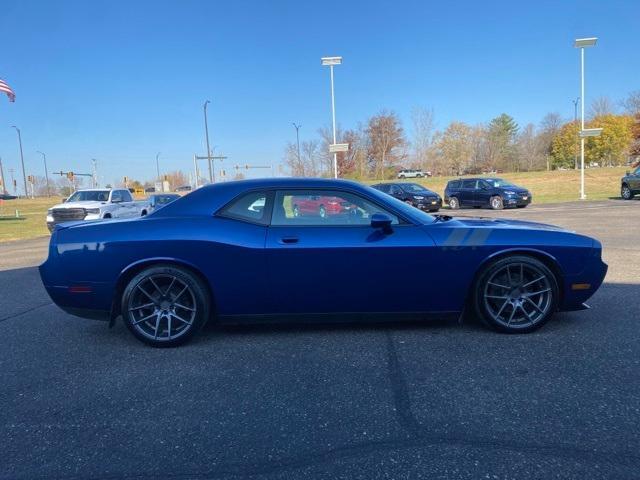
284 90 640 179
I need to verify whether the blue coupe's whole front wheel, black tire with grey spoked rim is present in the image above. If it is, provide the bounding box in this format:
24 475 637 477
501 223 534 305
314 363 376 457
472 255 560 333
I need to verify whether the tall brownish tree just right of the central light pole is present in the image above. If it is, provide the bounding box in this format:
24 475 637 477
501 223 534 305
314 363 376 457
367 110 407 178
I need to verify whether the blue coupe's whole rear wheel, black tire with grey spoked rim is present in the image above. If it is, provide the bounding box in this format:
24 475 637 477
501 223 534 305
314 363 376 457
121 265 210 347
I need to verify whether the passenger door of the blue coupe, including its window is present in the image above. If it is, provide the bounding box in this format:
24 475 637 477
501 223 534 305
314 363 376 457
266 190 437 314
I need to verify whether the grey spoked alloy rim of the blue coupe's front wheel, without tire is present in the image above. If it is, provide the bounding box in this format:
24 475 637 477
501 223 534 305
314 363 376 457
483 263 553 329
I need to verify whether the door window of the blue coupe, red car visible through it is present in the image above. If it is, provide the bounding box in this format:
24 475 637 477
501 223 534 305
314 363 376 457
271 190 399 226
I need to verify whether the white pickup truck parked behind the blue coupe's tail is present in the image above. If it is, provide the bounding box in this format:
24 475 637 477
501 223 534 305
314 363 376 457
47 188 145 232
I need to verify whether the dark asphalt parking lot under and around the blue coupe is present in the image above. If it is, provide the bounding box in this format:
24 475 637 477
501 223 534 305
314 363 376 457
0 201 640 480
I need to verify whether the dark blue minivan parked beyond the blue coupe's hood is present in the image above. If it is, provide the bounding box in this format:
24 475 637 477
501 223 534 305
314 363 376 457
444 178 531 210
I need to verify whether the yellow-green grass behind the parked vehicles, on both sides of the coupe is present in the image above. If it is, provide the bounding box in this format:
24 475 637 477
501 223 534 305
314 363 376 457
0 168 626 242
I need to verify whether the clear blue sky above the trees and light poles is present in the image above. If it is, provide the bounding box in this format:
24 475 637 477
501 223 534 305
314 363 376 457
0 0 640 191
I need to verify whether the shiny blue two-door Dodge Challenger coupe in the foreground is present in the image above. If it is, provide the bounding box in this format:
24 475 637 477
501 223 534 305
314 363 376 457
40 178 607 347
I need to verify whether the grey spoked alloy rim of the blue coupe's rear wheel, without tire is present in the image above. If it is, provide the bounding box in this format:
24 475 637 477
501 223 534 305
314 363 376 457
127 273 197 342
